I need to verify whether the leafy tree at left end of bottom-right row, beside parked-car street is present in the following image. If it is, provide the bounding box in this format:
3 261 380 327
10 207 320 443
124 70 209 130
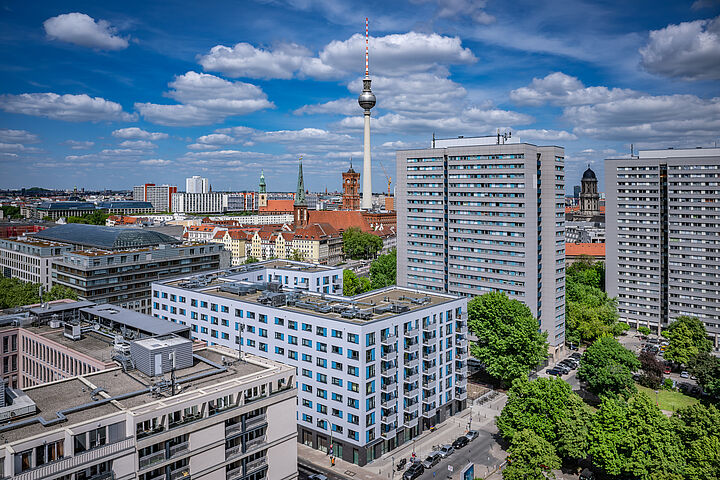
495 376 575 443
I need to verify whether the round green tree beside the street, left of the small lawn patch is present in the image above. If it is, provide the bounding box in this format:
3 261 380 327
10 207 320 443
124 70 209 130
577 337 640 397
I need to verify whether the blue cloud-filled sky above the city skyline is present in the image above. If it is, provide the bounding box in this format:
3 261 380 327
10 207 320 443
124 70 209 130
0 0 720 192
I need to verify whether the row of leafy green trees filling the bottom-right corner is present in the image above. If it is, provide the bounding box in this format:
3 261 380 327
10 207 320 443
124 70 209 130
497 377 720 480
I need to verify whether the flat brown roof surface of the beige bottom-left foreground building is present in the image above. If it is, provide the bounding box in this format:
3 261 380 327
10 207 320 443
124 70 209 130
0 346 276 443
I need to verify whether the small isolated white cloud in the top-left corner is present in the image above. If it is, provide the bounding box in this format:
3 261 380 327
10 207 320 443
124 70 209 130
43 12 128 50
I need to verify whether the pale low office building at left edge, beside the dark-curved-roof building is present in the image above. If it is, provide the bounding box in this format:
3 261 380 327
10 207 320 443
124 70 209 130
0 238 74 290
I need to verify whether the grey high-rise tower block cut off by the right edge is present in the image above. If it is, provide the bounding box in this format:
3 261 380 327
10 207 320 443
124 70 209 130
605 148 720 349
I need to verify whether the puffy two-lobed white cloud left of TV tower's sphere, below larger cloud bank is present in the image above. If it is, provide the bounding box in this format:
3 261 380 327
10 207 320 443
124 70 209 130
135 71 274 126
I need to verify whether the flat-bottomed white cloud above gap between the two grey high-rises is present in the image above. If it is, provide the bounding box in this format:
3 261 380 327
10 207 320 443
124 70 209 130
510 72 641 106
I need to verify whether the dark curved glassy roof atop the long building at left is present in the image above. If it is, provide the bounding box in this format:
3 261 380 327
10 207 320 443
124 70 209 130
33 223 181 250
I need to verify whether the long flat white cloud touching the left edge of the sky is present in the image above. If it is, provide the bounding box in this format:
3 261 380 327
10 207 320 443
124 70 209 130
0 93 136 122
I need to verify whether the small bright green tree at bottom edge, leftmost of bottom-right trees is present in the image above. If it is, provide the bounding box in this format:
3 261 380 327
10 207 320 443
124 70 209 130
502 429 560 480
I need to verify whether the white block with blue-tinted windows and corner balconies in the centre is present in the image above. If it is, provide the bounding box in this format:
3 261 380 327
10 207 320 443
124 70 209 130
153 261 468 465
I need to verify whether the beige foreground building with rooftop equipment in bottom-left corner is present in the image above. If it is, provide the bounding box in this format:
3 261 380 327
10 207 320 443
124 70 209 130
0 335 297 480
